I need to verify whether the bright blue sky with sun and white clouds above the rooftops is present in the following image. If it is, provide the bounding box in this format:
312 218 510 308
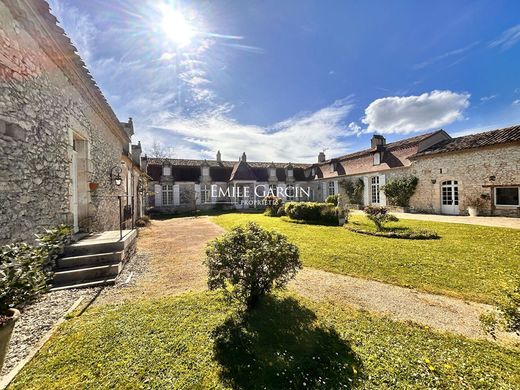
50 0 520 162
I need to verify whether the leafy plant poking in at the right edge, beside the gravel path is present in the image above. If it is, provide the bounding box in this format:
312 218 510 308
480 279 520 338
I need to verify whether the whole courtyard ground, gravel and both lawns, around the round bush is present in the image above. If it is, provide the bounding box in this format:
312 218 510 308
5 213 520 389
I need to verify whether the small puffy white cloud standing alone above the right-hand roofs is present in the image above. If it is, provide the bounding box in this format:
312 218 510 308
362 91 470 134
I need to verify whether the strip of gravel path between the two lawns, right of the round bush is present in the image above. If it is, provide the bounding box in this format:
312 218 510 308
290 267 520 342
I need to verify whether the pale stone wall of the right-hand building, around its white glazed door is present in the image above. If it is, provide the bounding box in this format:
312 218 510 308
410 143 520 216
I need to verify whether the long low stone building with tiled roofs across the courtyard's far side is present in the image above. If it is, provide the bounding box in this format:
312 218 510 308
147 126 520 216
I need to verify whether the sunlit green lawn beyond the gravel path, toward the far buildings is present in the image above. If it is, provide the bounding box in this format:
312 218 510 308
213 213 520 303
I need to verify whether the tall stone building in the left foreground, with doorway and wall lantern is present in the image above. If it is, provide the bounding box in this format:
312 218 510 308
0 0 142 244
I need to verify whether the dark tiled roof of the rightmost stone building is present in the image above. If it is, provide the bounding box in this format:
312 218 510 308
414 125 520 157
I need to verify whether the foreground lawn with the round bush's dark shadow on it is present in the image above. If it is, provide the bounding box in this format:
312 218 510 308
10 292 520 389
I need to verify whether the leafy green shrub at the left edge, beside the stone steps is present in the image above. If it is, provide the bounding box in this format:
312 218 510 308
0 243 49 326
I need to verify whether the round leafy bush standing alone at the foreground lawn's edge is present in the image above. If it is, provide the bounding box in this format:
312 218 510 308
205 222 302 309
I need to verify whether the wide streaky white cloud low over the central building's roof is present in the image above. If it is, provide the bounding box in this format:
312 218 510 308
143 98 353 162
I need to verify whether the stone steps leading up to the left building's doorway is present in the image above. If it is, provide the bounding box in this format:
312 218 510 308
51 230 137 291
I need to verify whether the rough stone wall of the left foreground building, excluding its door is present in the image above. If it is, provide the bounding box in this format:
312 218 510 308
0 2 129 244
